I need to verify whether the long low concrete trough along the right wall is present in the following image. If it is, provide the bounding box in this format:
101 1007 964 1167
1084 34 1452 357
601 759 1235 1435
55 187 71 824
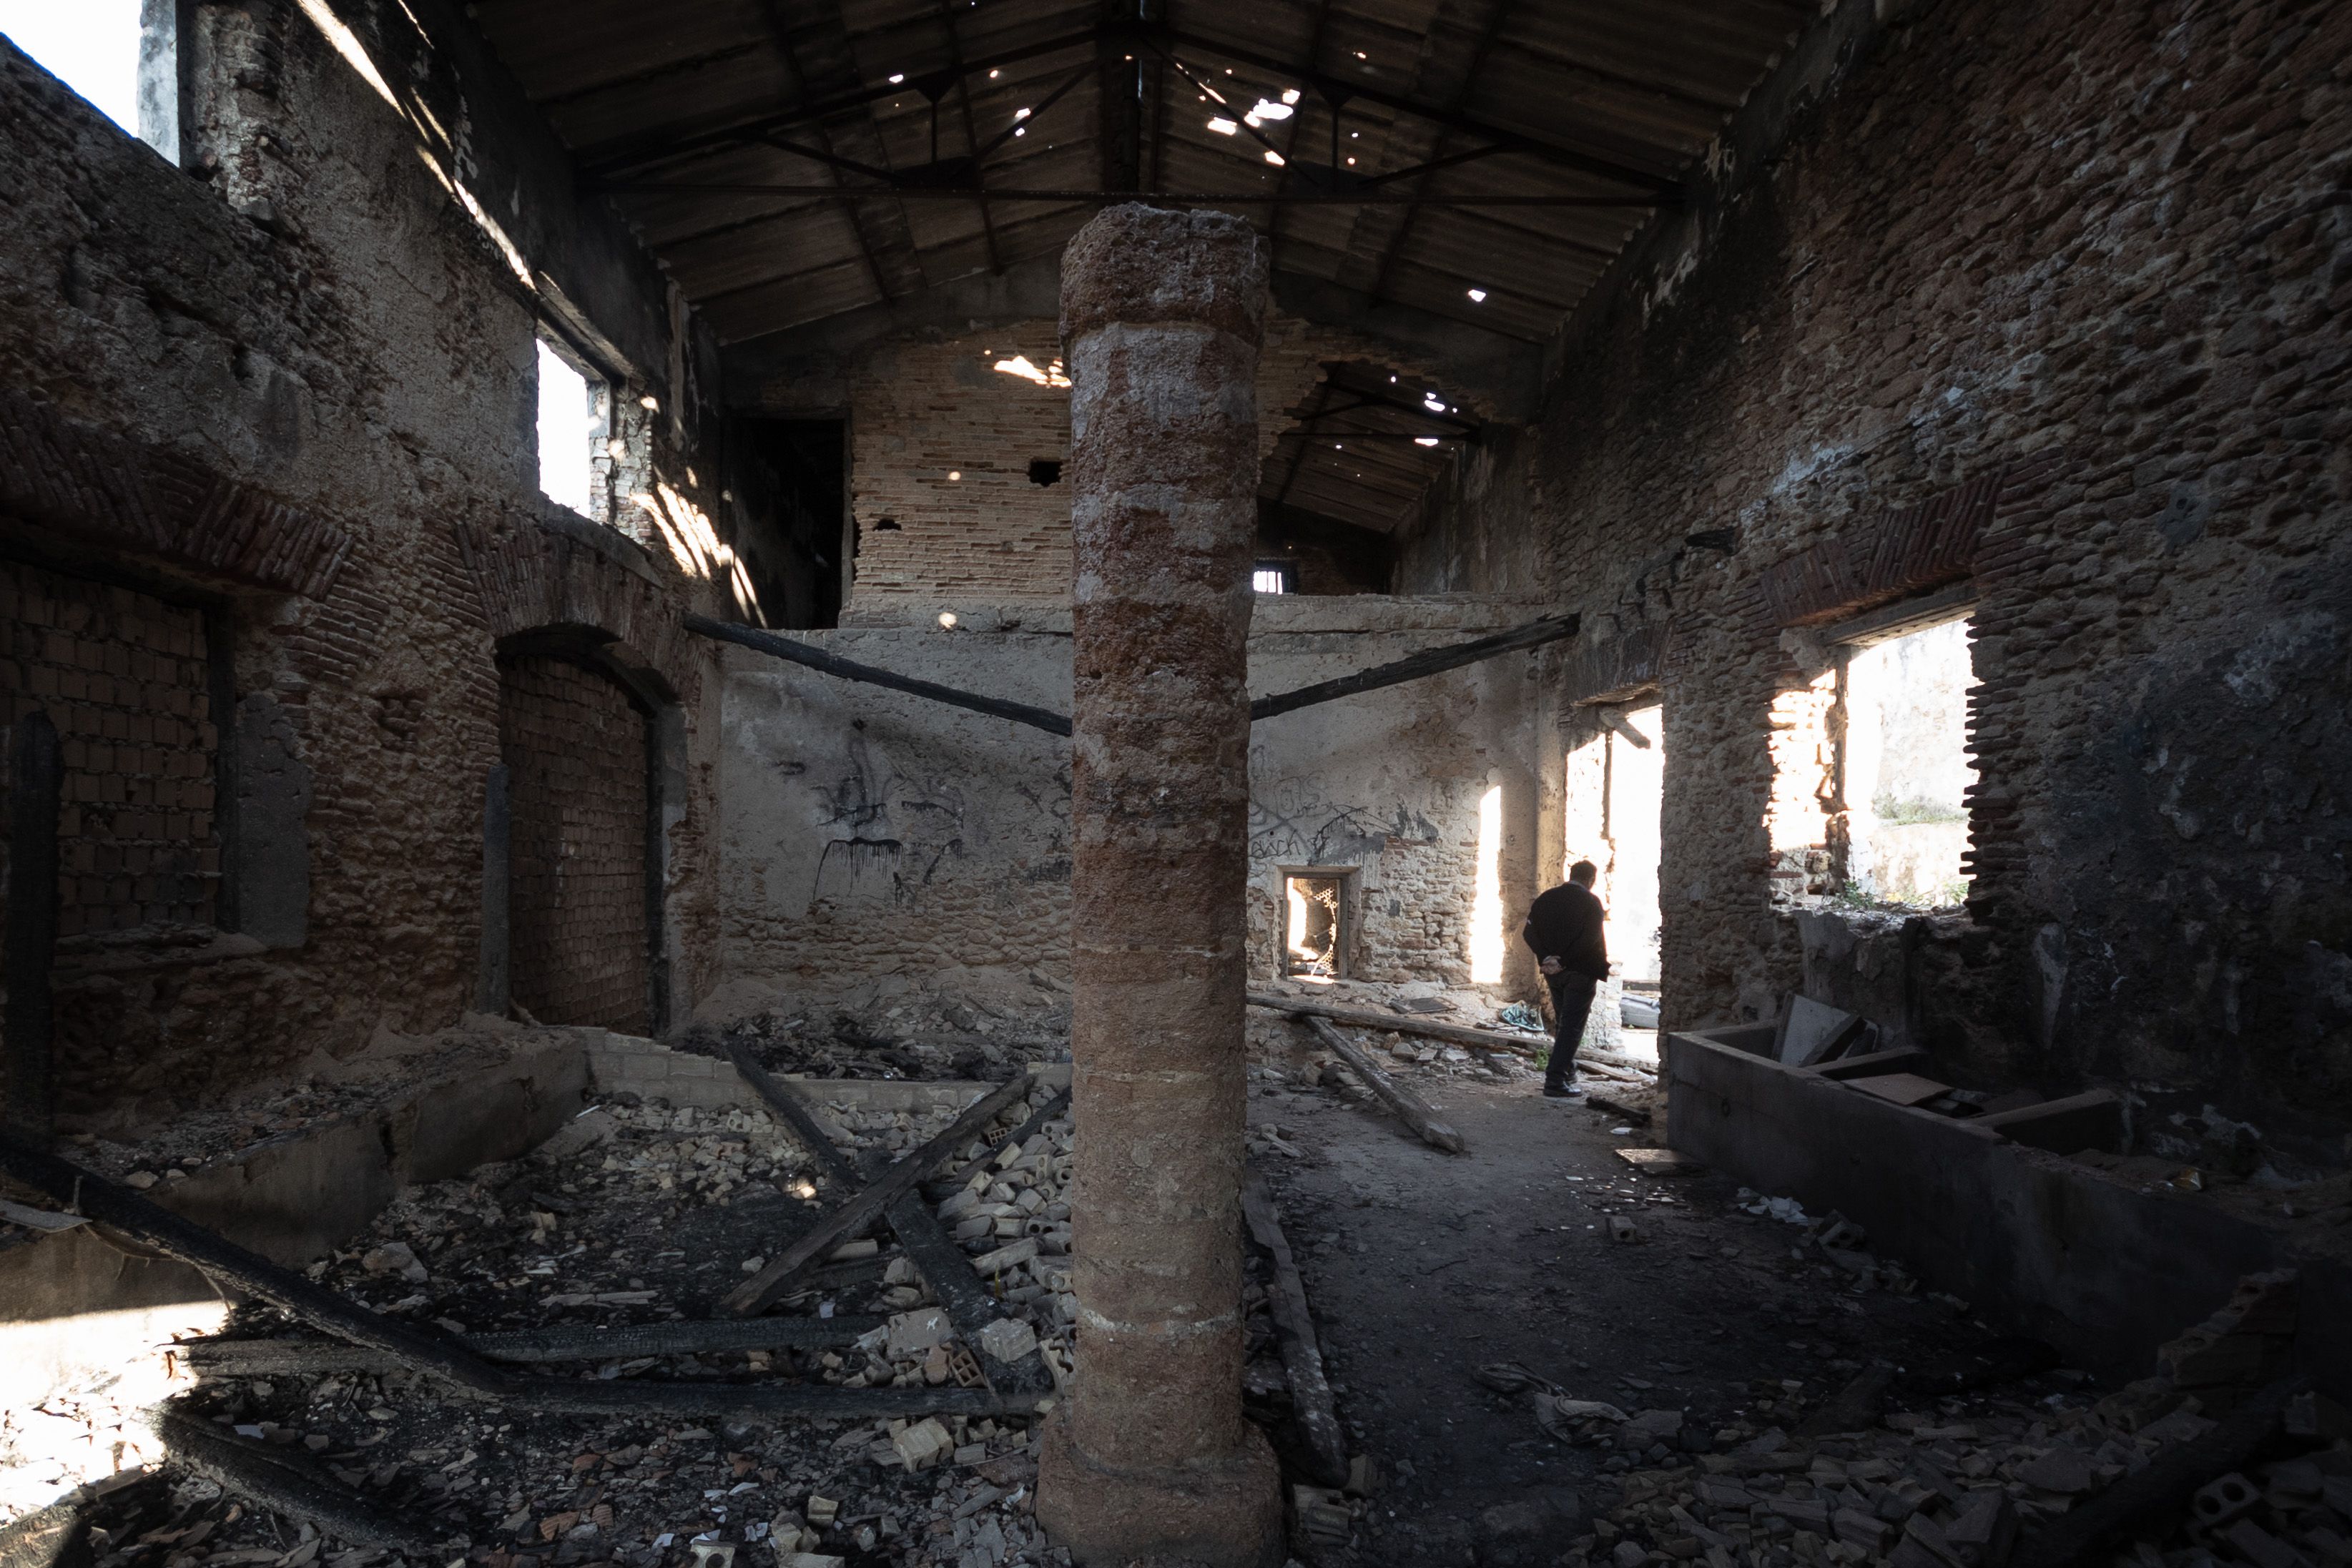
1663 1025 2352 1396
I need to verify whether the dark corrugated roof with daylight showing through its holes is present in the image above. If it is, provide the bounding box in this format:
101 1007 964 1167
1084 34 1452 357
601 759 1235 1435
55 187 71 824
471 0 1816 529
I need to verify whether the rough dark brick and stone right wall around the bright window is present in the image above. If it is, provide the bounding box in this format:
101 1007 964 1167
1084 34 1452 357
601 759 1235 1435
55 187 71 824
1411 0 2352 1130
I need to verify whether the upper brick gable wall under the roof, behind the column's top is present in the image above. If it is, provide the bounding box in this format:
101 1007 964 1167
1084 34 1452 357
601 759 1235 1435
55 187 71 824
845 317 1421 623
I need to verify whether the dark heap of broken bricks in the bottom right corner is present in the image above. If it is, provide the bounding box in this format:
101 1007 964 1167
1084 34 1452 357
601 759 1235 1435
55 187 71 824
1552 1269 2352 1568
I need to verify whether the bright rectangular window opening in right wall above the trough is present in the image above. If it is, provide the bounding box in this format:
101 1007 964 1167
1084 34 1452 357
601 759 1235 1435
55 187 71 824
1839 618 1976 907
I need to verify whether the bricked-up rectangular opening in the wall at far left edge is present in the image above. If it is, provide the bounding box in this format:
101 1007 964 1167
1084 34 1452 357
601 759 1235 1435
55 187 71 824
0 560 221 940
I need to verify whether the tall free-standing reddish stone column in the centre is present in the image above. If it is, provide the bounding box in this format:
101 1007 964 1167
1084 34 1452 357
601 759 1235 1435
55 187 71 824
1037 204 1282 1568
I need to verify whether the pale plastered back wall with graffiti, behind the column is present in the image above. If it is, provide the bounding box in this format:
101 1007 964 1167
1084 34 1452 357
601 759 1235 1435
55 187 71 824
719 595 1560 1011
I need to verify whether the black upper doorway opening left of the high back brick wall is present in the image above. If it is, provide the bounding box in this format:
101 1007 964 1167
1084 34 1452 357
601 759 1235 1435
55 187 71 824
719 418 849 630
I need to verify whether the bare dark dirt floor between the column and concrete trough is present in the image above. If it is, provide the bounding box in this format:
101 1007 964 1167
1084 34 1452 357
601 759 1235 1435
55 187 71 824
1251 1052 2126 1568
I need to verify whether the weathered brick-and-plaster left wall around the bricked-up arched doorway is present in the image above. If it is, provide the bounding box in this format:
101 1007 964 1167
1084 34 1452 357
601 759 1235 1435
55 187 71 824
0 0 717 1126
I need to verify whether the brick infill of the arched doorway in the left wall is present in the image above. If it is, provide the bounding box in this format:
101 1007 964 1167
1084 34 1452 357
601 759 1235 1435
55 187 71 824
498 659 649 1035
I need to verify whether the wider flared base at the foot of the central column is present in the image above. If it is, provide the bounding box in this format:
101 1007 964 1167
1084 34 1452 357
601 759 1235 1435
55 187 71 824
1037 1404 1284 1568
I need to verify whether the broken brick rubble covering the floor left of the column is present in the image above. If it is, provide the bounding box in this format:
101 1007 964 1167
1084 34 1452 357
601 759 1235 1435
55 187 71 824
0 1086 1075 1568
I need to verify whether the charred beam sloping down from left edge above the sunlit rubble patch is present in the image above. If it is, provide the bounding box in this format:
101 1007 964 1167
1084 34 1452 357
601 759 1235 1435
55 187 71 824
0 1133 513 1394
